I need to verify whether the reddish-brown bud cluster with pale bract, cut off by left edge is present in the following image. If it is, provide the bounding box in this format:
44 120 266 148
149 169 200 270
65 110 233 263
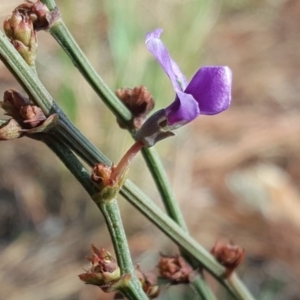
0 89 58 140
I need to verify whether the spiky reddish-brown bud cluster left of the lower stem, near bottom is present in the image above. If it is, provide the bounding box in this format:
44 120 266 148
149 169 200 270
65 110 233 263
79 245 120 291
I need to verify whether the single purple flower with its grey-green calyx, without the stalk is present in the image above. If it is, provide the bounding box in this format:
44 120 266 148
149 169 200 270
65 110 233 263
136 28 232 147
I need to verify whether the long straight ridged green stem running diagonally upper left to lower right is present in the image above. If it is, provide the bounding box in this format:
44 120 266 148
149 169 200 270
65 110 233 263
0 31 253 300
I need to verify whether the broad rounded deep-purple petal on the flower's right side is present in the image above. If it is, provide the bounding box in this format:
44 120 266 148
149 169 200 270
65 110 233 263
184 67 232 115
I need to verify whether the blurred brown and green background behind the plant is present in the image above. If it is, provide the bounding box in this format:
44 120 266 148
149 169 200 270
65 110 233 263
0 0 300 300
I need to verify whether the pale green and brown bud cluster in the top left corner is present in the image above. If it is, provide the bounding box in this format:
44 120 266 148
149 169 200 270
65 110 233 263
3 0 59 66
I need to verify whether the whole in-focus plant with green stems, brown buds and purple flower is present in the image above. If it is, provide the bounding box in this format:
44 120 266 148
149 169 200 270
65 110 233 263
0 0 253 300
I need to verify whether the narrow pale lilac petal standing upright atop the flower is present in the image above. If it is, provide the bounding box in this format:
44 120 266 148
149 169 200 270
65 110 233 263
146 28 187 91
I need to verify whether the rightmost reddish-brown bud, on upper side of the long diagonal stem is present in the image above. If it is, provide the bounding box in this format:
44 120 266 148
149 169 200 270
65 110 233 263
211 241 245 278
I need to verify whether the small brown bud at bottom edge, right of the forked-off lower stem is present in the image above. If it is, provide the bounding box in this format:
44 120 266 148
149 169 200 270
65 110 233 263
135 265 159 299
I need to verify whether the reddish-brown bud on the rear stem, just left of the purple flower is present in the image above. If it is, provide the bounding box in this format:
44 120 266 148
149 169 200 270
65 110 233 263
116 86 154 129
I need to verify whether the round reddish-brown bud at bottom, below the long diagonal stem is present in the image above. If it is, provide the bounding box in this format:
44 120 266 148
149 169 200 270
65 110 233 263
157 255 193 284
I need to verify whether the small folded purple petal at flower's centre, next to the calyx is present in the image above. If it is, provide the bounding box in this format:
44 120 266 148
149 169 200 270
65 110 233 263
165 92 200 129
